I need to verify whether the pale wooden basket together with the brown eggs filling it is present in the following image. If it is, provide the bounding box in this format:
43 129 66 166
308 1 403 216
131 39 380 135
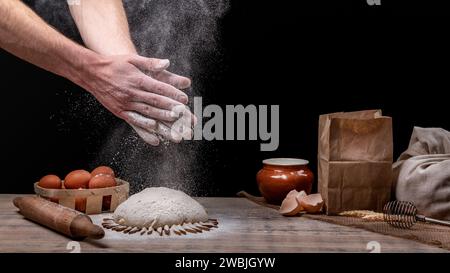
34 166 130 214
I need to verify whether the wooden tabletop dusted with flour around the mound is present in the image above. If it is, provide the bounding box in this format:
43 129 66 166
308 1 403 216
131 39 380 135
0 195 446 253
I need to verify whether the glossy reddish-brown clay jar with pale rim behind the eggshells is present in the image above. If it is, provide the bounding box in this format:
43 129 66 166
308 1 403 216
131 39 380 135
256 158 314 205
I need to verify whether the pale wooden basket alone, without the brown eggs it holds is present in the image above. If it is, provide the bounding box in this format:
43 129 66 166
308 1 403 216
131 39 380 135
34 178 130 214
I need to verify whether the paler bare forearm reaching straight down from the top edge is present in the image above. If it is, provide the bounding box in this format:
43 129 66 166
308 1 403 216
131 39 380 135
69 0 136 55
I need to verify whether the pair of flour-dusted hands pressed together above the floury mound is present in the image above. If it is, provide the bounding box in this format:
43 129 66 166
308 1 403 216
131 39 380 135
81 52 195 146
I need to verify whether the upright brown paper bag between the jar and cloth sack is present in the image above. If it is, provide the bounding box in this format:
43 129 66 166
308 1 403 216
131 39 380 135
318 110 393 215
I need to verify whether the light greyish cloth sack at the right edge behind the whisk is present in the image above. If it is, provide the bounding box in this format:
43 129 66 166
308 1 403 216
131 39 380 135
394 127 450 220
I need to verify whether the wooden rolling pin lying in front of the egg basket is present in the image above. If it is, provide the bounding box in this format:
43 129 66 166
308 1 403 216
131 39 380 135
13 196 105 240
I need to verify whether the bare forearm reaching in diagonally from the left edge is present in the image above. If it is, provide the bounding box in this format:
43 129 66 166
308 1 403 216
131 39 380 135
0 0 100 84
